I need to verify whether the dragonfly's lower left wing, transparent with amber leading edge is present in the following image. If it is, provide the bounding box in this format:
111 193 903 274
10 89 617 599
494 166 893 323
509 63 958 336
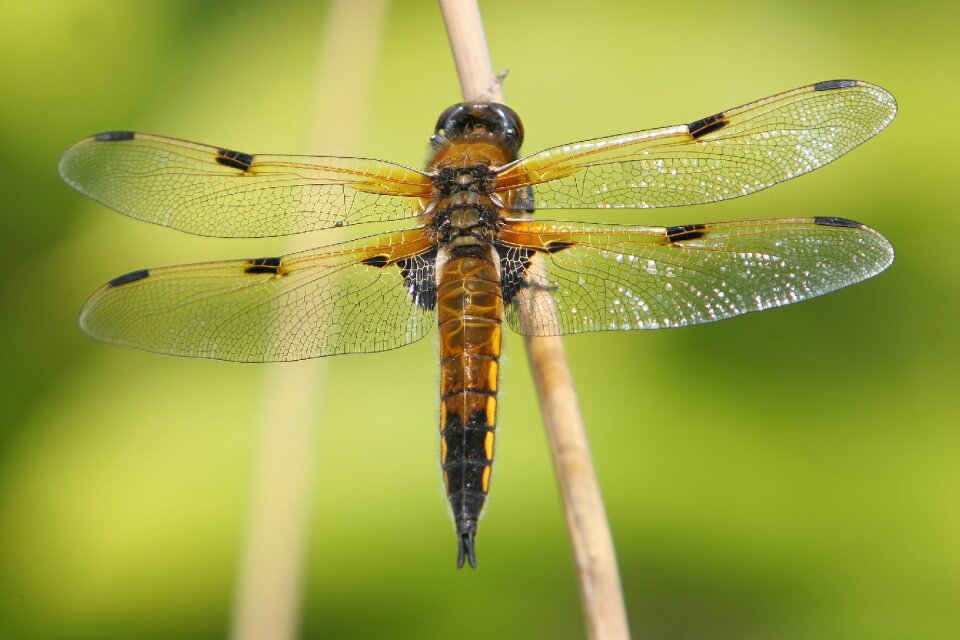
80 229 436 362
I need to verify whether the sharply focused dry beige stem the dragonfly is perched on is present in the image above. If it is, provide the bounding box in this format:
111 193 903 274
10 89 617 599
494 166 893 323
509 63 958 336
440 0 630 640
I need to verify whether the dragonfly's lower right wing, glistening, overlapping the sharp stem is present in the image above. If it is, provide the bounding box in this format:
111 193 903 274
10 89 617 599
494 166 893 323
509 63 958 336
500 218 893 336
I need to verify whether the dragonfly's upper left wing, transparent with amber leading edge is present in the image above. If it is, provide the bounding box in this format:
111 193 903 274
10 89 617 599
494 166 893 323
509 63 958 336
60 131 433 238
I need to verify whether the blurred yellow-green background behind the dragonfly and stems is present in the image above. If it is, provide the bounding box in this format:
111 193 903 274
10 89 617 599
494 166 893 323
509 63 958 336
0 0 960 640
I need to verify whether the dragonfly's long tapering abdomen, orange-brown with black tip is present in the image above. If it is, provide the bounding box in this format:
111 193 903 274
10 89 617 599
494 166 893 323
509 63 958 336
437 246 503 566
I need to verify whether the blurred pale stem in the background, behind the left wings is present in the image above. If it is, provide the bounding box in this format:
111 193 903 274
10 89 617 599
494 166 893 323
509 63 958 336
231 0 386 640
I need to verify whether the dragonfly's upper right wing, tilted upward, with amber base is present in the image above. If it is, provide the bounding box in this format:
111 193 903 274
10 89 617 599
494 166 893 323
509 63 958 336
496 80 897 209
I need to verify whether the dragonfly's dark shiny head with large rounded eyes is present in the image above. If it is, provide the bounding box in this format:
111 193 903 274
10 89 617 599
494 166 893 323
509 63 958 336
430 102 523 155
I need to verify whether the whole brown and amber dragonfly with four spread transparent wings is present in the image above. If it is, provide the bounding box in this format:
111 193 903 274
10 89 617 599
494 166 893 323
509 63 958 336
59 80 897 568
